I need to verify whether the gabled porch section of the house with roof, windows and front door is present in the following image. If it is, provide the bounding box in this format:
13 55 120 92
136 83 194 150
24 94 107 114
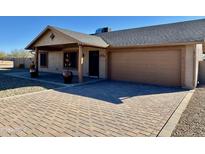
26 26 108 83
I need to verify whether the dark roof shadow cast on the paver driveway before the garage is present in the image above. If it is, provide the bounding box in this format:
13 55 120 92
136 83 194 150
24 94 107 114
57 80 185 104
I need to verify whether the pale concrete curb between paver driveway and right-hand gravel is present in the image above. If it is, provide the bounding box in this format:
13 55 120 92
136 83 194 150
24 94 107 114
157 90 195 137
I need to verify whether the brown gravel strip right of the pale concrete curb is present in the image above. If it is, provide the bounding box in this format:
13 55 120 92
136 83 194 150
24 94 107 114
172 87 205 137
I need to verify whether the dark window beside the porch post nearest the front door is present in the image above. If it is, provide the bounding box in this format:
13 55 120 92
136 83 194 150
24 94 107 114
63 52 78 68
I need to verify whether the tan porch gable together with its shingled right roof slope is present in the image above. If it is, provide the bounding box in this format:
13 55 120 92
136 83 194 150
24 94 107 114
26 26 108 49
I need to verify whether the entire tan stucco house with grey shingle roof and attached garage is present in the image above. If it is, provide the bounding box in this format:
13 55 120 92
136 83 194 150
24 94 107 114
26 19 205 89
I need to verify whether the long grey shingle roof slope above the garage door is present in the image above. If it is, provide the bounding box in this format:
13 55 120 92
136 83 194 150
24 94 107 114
96 19 205 47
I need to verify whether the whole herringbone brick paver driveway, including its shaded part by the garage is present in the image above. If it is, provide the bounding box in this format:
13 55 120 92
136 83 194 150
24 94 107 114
0 81 187 136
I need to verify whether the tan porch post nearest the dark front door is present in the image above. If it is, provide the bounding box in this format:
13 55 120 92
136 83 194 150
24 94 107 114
78 45 83 82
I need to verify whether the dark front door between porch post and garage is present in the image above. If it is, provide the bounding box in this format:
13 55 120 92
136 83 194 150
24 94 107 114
89 51 99 77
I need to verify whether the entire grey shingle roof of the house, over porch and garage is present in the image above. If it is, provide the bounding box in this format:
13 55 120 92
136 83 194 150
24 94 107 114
26 19 205 49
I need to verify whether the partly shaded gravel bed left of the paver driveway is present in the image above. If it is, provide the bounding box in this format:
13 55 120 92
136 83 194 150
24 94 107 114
0 73 60 98
